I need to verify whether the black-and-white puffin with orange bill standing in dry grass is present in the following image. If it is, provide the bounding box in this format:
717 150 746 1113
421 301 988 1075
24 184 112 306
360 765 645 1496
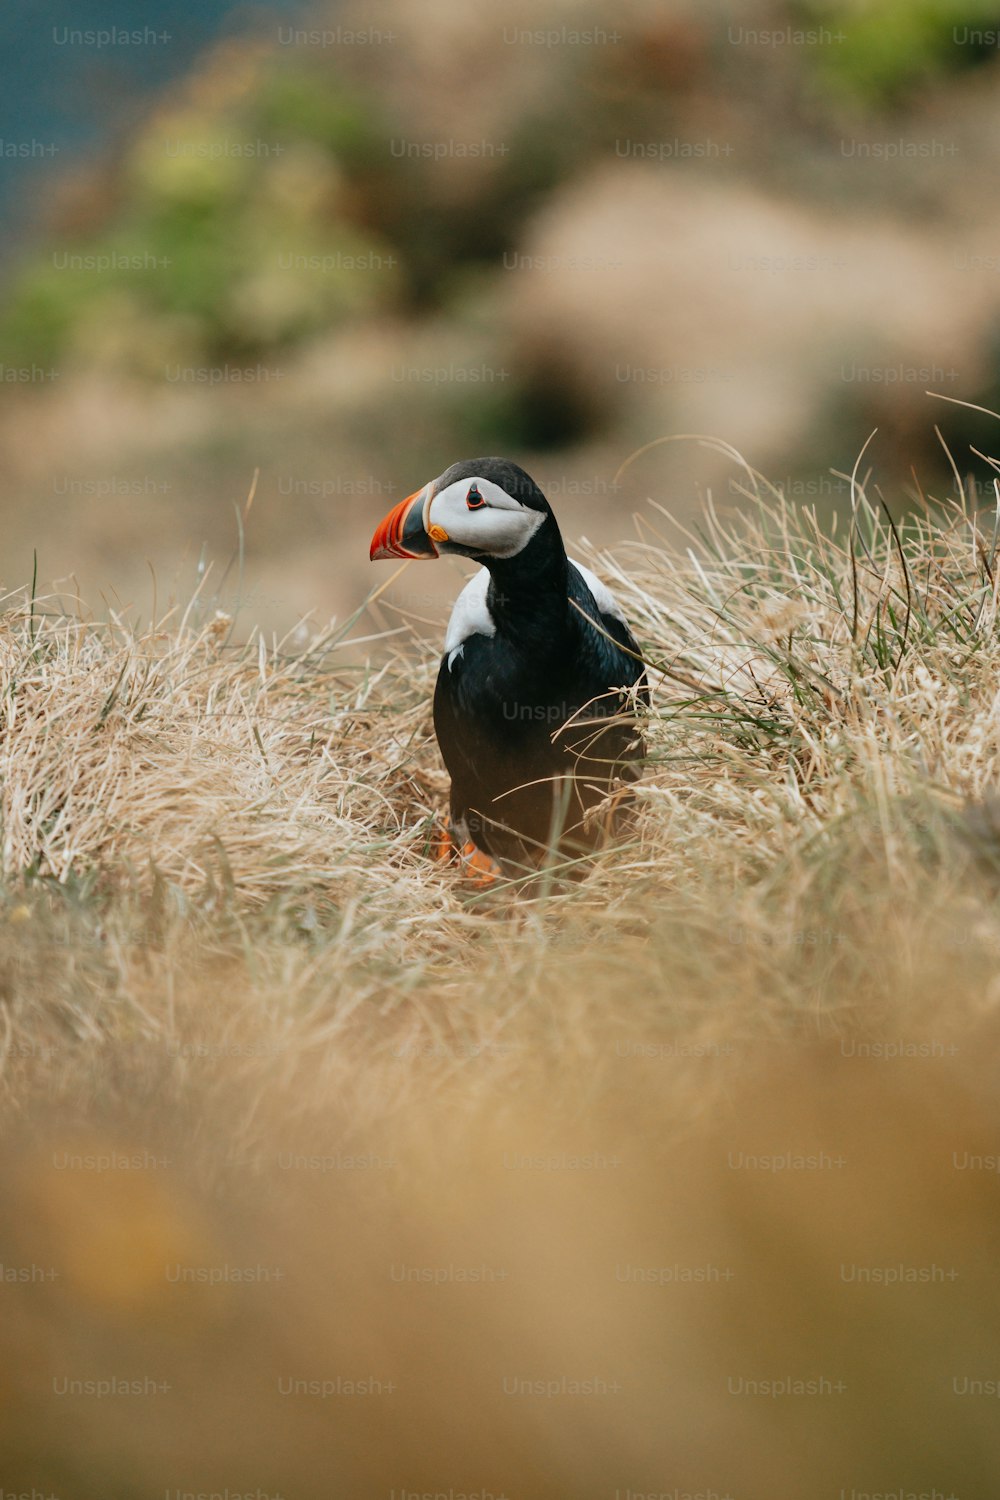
370 458 649 885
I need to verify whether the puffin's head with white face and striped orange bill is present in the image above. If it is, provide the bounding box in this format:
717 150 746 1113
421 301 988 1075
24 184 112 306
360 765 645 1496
370 459 555 563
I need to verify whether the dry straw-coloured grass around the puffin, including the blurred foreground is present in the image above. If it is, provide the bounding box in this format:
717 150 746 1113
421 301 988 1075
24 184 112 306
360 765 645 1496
0 453 1000 1497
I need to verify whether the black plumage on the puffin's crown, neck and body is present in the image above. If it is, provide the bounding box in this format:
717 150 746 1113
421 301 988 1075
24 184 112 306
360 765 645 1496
433 461 648 864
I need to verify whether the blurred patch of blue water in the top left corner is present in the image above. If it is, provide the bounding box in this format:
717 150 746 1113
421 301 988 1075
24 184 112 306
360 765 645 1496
0 0 303 252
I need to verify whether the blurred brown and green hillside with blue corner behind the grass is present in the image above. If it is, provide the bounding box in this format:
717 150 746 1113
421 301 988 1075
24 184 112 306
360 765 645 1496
0 0 1000 630
